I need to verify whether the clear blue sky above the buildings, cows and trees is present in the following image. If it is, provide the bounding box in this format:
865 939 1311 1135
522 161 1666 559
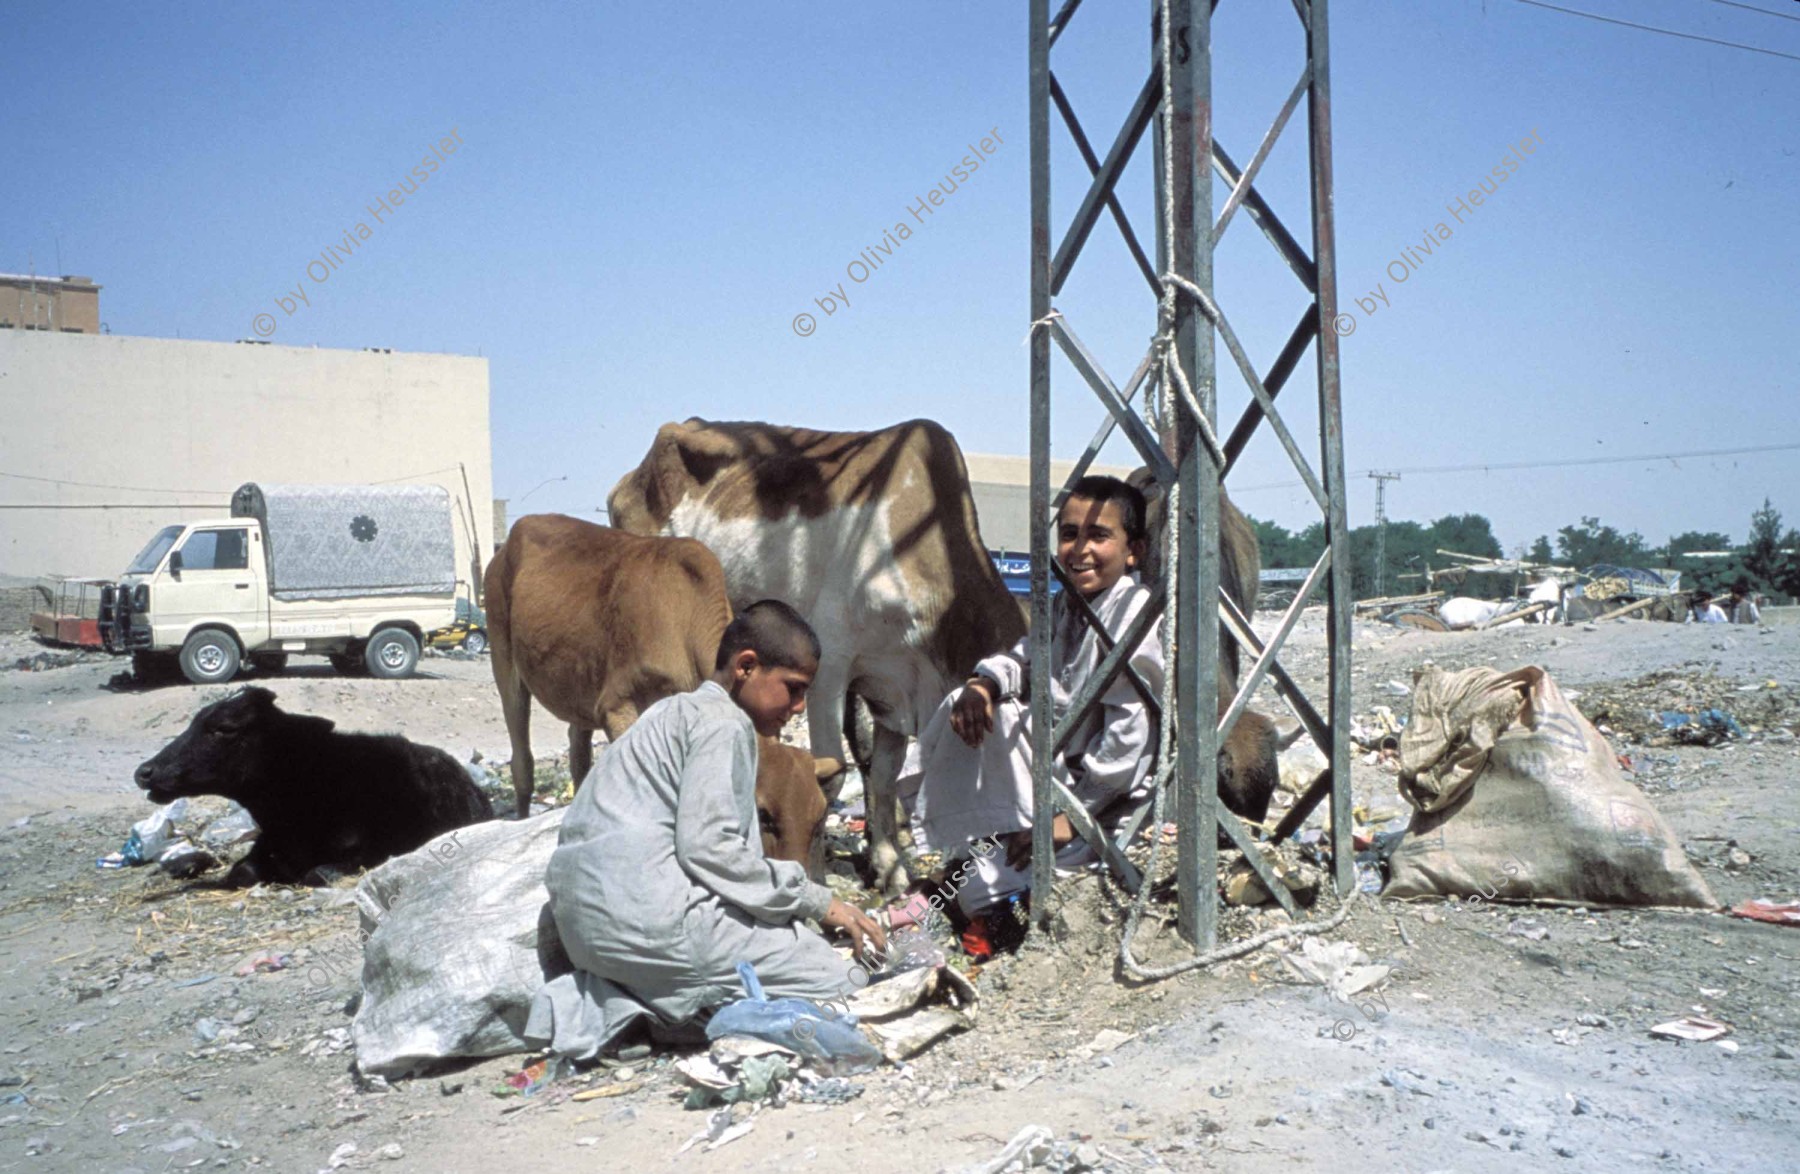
0 0 1800 549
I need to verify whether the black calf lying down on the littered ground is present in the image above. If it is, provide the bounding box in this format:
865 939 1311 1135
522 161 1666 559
137 686 493 888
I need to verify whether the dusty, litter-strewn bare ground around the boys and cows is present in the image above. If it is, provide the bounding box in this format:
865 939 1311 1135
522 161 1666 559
0 619 1800 1172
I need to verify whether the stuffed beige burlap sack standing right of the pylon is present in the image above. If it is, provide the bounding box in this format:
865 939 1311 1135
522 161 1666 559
1382 668 1719 909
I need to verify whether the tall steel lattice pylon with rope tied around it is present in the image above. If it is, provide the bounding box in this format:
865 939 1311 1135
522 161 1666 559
1030 0 1355 947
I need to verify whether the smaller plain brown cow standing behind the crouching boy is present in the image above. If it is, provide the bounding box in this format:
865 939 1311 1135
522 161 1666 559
484 513 841 875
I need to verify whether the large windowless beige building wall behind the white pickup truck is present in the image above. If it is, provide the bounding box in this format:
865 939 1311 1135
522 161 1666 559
0 330 493 582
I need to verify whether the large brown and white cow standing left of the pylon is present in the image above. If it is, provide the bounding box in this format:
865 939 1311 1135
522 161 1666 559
607 420 1026 888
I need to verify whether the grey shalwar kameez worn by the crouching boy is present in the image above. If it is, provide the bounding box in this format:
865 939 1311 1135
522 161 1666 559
527 681 851 1059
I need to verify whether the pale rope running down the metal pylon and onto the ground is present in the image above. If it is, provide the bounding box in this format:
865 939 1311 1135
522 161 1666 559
1120 0 1361 981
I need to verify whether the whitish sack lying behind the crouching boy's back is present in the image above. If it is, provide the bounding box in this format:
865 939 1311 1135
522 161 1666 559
349 808 574 1077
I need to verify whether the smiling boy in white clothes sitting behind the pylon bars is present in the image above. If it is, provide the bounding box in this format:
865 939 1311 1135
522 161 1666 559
889 477 1163 936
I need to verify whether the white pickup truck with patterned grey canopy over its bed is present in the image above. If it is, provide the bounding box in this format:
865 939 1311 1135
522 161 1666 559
99 484 473 684
